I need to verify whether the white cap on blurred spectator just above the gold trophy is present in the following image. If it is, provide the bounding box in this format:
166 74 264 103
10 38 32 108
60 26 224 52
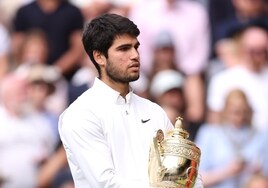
150 70 184 97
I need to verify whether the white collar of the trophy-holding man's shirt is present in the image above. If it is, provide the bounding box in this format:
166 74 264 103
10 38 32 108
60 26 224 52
92 77 133 104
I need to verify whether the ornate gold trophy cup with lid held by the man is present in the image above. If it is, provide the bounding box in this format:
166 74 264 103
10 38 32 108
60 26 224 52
149 117 201 188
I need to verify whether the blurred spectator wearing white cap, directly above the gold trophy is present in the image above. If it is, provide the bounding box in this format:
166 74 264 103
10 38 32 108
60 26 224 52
149 69 200 140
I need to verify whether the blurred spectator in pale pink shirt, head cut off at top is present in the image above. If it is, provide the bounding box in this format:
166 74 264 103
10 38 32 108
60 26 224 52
129 0 209 131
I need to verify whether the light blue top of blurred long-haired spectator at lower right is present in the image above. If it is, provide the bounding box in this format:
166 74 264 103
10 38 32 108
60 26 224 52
195 124 268 188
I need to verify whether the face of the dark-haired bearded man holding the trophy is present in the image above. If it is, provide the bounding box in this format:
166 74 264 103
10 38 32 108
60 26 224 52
103 35 140 83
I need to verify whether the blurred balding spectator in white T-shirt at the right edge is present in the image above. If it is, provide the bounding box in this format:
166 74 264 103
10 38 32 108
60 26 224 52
207 22 268 130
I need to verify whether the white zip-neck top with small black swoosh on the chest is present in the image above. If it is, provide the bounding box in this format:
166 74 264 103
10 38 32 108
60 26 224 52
59 78 173 188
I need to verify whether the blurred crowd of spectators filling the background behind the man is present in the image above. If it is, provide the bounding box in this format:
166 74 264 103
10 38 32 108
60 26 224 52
0 0 268 188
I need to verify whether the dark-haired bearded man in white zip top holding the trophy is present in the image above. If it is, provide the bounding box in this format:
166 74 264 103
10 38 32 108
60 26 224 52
59 14 201 188
